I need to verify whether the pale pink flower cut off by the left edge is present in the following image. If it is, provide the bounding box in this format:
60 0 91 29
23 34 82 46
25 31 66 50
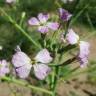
0 60 10 77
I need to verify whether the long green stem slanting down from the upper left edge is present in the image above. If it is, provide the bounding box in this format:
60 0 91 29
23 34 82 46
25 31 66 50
0 8 41 49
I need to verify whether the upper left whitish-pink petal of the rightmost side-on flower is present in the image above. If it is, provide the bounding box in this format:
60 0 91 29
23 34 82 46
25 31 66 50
66 29 79 45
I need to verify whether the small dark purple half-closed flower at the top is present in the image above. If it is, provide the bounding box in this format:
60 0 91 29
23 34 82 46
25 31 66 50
59 8 72 21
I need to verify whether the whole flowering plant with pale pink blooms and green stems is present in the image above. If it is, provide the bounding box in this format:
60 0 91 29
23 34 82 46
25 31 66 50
0 0 94 96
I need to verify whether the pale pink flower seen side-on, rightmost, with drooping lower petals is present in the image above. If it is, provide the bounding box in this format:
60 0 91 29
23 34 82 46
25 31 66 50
66 29 90 67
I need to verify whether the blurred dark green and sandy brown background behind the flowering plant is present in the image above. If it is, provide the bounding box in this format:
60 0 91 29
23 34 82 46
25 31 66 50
0 0 96 96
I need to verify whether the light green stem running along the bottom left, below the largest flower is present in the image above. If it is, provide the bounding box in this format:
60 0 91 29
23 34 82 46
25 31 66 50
2 76 53 95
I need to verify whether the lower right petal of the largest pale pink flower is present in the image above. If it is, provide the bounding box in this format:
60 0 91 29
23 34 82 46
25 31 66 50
33 64 51 80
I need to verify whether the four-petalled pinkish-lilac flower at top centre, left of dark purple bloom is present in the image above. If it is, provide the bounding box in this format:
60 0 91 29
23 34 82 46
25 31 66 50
28 13 59 33
